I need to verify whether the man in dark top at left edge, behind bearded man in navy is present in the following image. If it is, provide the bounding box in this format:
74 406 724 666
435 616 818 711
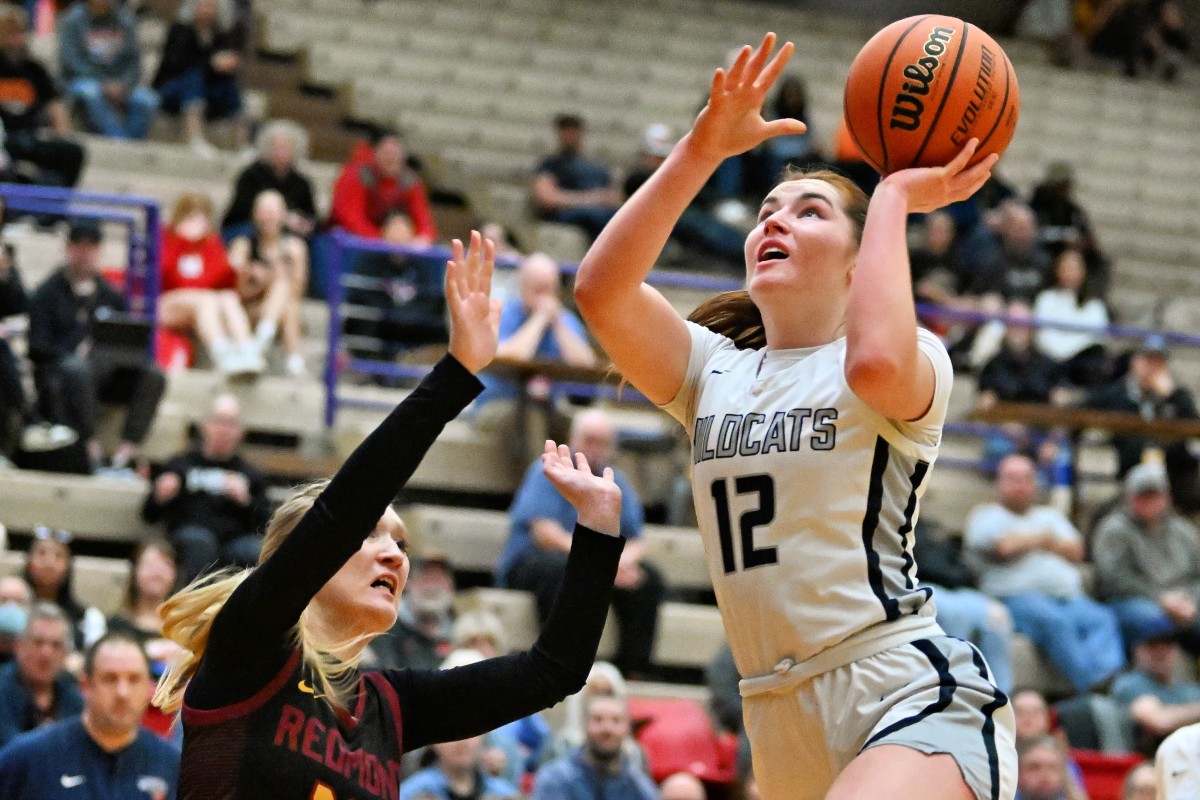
0 603 83 747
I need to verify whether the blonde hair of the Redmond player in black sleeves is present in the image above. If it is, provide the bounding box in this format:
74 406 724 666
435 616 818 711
151 480 368 712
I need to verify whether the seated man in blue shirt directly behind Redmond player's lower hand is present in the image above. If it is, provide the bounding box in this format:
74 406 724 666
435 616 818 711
496 409 665 678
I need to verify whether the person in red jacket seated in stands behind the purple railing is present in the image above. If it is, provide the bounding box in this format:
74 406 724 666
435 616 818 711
330 130 437 245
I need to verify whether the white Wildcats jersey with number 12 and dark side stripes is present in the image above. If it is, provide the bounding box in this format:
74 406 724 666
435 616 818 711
664 323 953 676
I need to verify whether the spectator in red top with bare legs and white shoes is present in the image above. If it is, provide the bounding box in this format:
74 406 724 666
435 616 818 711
158 192 265 374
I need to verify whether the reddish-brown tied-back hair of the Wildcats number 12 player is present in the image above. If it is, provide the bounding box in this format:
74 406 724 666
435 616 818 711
688 167 870 350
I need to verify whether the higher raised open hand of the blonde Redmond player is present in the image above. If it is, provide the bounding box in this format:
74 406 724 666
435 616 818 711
445 230 500 373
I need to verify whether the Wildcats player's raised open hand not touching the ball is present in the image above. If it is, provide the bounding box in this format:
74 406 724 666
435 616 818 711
689 34 808 160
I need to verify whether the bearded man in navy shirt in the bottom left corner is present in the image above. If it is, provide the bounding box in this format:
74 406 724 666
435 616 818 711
0 633 179 800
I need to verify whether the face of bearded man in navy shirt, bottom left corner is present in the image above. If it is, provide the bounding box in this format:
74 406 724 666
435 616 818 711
80 640 154 734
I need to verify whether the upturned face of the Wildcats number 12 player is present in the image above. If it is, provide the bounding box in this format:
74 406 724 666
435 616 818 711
745 179 858 302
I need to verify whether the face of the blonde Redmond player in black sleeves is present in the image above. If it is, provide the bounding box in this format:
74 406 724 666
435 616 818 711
313 509 409 637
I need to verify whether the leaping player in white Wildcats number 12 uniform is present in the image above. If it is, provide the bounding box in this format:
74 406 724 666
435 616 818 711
575 35 1016 800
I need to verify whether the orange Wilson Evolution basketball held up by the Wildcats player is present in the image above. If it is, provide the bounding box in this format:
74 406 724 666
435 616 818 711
845 14 1021 175
